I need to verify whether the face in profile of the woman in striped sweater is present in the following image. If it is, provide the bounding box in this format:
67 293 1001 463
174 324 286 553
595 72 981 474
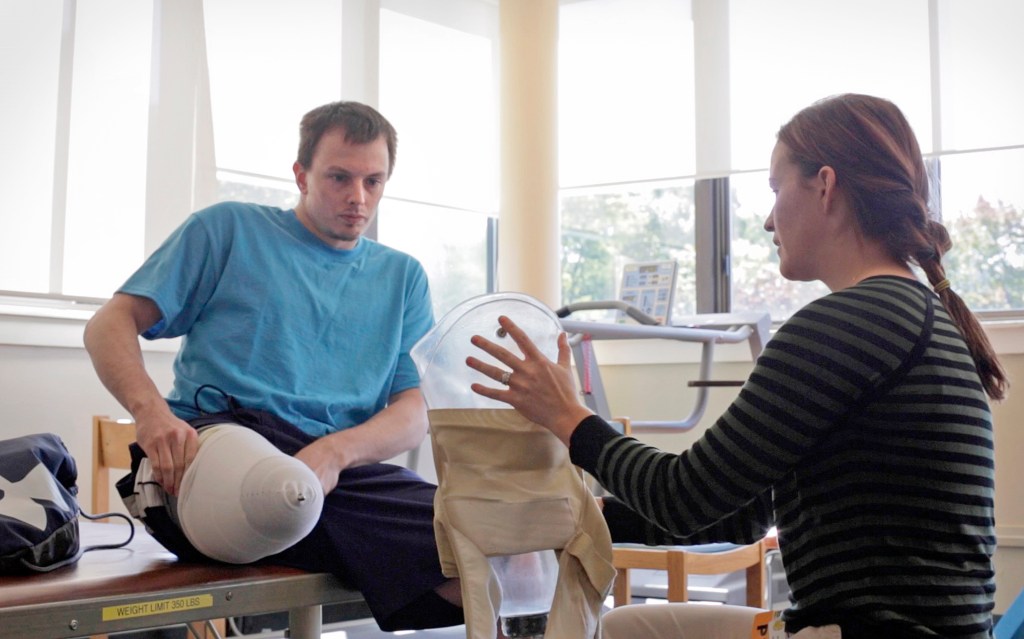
765 142 826 282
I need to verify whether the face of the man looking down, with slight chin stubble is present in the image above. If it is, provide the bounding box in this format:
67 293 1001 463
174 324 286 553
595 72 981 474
292 128 389 249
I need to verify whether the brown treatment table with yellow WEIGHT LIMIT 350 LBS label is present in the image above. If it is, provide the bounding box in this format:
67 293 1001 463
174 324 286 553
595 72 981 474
0 521 364 639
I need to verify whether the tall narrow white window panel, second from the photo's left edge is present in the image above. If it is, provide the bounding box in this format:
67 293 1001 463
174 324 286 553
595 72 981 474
57 0 153 297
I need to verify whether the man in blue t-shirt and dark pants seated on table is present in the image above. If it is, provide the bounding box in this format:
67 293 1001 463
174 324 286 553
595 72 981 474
85 102 461 630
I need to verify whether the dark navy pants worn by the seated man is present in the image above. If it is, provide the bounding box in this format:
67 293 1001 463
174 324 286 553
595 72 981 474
124 407 464 631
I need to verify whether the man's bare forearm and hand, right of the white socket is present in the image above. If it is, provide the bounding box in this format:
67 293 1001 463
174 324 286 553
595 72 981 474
295 388 427 493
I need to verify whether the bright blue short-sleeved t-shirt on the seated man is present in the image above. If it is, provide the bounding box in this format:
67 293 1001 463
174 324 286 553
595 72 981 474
119 203 433 436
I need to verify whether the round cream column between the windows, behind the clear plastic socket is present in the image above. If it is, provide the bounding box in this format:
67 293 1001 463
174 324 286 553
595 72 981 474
498 0 561 308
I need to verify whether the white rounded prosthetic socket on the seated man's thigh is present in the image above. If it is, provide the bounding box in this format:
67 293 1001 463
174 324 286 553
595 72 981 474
177 424 324 563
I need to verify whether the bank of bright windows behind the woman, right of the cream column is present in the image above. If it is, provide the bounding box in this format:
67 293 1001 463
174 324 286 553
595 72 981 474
559 0 1024 321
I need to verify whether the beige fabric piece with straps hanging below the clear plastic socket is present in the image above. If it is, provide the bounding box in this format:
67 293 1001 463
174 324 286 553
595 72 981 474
428 409 615 639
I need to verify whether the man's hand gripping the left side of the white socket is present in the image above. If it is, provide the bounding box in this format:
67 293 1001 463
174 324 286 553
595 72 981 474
135 412 199 495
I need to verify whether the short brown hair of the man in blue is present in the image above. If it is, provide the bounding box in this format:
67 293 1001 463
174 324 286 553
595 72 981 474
297 101 398 177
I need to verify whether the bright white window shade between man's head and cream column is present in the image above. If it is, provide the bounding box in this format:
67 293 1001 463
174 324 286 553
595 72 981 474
380 10 498 214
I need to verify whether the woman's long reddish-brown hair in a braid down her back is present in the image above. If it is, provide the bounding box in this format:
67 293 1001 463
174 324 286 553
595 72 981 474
778 93 1009 399
